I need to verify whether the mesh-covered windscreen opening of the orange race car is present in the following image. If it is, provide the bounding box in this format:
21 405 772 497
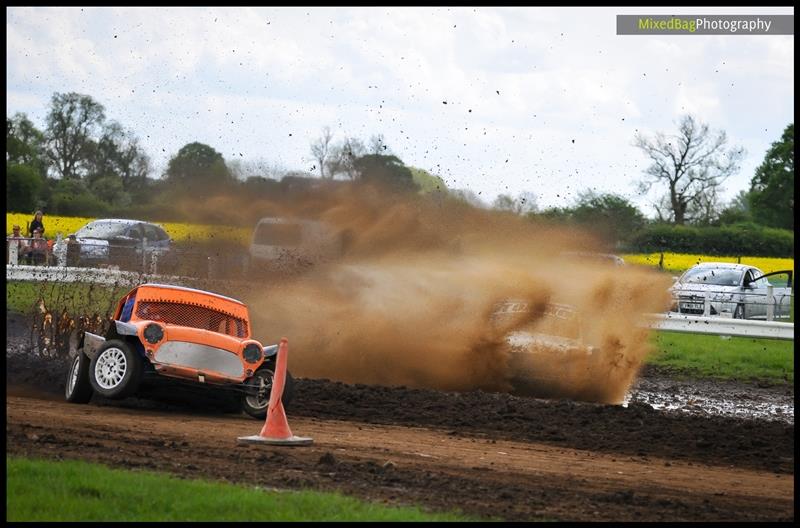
136 300 248 338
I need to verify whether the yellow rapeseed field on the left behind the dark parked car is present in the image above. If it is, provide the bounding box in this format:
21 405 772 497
6 213 253 245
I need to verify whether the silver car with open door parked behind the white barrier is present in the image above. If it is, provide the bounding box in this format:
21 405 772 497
670 262 793 319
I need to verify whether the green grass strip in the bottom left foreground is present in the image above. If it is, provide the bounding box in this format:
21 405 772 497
6 456 477 521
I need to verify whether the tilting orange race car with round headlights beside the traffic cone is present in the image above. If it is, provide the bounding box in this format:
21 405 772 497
66 284 293 419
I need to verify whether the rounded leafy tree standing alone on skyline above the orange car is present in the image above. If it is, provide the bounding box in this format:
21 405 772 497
166 143 235 194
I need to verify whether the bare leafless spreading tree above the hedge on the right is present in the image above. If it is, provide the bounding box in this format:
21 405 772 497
634 115 744 225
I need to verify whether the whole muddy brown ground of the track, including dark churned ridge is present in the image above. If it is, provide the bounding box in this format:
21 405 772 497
6 316 794 521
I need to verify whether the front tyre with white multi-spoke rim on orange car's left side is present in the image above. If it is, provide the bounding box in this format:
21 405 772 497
89 339 144 399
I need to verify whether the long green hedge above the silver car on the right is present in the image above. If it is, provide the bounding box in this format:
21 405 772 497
628 223 794 257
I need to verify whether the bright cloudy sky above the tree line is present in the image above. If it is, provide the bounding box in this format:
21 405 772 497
6 7 794 216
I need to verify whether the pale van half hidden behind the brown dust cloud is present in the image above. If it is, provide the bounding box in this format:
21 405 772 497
245 217 344 271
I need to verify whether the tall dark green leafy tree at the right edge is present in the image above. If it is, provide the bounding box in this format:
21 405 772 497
750 123 794 229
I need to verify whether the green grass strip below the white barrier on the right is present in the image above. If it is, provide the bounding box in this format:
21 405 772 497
647 332 794 383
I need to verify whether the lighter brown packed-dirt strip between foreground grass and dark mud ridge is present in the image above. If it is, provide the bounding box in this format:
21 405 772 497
6 380 794 520
